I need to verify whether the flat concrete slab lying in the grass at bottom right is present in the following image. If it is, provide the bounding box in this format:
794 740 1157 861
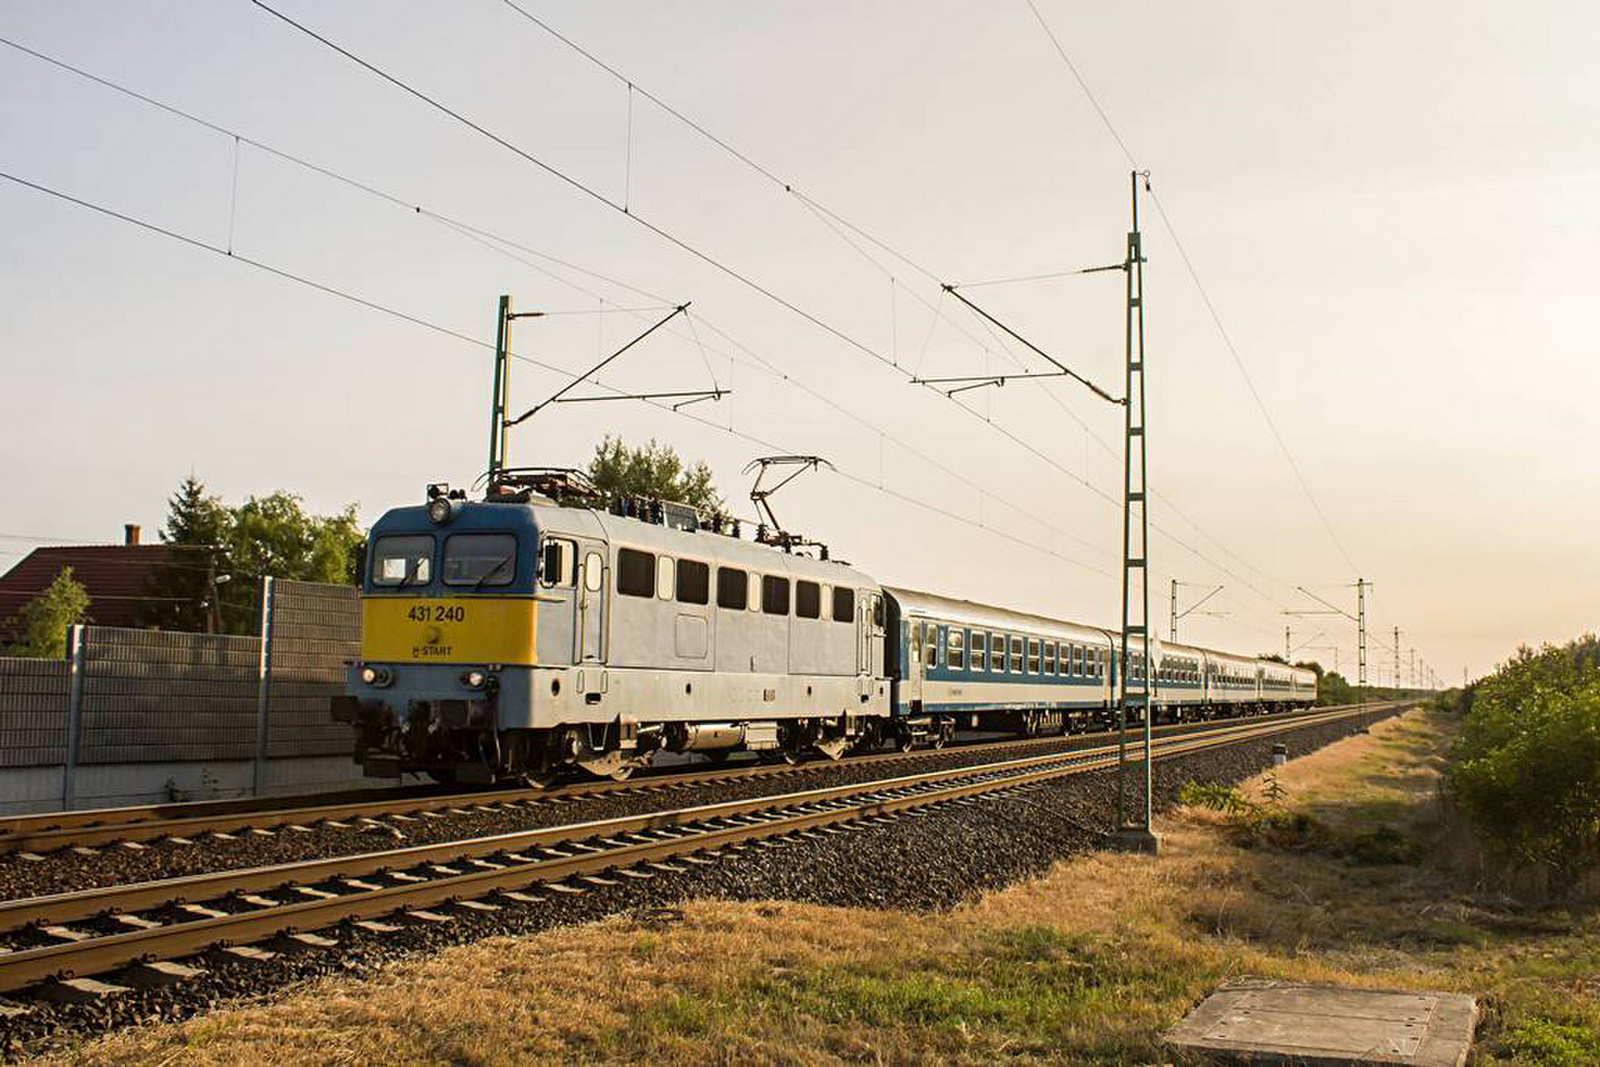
1166 979 1477 1067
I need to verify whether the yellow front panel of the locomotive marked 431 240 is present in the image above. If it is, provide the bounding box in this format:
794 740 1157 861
362 597 538 667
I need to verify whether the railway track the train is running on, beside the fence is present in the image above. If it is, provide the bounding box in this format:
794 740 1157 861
0 704 1401 856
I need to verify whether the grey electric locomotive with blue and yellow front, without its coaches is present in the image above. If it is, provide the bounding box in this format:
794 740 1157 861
334 470 893 782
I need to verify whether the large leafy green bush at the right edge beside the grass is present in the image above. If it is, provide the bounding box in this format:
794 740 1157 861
1448 637 1600 896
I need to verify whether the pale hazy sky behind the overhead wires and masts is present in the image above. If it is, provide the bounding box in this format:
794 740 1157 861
0 0 1600 681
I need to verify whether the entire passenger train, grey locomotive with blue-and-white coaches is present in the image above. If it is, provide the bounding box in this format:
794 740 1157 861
333 472 1317 782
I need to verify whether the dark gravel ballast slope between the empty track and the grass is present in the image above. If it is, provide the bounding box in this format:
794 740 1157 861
0 710 1398 1059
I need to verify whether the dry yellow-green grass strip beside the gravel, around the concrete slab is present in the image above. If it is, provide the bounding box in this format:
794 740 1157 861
43 712 1600 1064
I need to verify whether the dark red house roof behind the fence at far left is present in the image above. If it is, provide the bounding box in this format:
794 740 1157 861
0 523 174 645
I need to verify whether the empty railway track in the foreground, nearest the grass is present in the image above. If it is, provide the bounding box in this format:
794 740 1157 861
0 705 1382 995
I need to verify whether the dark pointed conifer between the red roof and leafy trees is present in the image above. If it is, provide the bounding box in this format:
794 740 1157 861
138 474 234 632
